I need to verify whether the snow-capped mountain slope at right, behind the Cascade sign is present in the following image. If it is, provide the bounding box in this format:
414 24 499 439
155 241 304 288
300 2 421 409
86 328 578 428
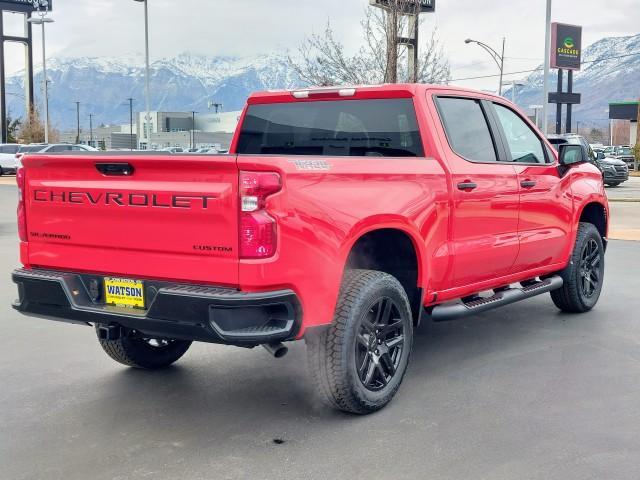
504 34 640 128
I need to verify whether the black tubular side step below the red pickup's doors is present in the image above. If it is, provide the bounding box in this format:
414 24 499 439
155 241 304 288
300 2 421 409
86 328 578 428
431 275 563 322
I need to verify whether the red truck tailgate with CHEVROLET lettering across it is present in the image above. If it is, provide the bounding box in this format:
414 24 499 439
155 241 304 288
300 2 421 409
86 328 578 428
23 154 238 285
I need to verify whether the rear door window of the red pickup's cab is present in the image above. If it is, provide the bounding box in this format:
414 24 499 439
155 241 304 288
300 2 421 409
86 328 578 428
437 97 497 162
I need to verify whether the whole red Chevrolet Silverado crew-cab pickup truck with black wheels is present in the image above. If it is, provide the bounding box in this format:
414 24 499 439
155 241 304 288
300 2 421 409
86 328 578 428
13 85 608 413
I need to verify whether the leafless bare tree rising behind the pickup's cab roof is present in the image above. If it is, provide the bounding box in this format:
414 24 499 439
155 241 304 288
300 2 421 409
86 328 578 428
287 0 450 86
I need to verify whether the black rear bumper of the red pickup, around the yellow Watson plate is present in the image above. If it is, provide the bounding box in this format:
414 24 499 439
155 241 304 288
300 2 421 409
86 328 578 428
13 269 302 346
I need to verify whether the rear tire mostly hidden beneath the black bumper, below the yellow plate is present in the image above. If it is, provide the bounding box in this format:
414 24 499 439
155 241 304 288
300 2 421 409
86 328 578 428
98 328 191 370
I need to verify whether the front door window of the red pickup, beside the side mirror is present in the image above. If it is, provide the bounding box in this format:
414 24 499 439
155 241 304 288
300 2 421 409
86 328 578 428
494 103 546 163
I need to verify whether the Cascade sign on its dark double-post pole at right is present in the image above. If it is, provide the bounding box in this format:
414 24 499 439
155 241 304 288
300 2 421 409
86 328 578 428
549 23 582 134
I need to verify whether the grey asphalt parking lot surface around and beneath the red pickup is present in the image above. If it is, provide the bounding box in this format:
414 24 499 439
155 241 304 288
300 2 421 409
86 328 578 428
0 185 640 480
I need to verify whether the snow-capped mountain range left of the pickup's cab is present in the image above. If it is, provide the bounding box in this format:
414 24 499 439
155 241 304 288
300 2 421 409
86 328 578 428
7 54 300 130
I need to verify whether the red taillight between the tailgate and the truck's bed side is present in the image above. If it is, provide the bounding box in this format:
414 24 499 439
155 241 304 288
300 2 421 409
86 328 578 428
240 172 282 258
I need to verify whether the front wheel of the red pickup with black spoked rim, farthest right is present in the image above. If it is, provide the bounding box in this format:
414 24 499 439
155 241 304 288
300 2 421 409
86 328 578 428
551 223 604 313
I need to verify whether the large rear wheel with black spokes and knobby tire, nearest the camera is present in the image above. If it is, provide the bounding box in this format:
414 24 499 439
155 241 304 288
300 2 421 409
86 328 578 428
306 270 413 415
